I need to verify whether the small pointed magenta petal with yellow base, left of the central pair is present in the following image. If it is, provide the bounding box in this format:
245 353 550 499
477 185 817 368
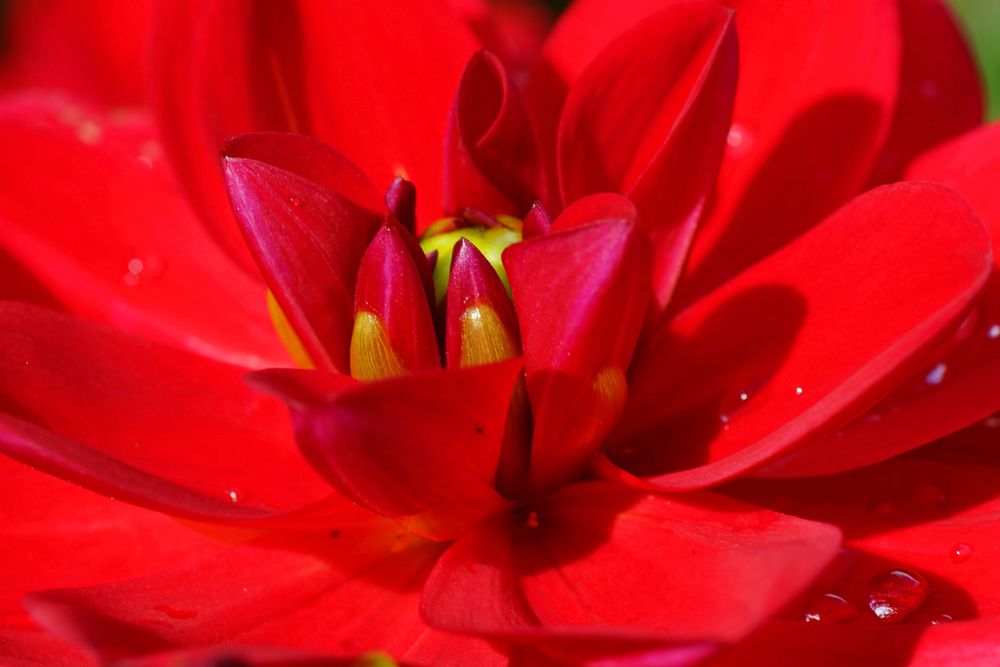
350 221 441 380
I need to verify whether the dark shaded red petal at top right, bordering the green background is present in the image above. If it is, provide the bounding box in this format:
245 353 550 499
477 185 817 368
869 0 983 185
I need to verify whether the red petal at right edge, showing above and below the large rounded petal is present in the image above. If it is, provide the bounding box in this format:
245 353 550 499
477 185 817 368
766 124 1000 476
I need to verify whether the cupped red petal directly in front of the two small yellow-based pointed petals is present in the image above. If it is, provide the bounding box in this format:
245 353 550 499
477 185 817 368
282 360 521 539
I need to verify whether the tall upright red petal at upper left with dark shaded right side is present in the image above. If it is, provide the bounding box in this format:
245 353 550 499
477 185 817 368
148 0 310 273
